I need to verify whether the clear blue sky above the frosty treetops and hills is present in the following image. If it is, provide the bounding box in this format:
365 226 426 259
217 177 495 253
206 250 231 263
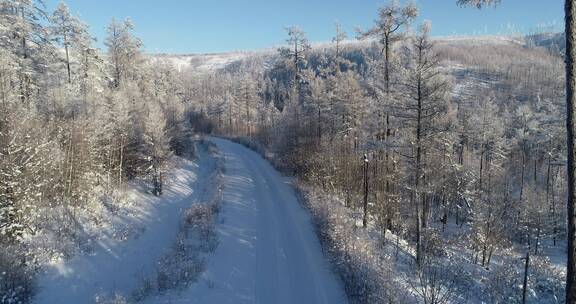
45 0 564 53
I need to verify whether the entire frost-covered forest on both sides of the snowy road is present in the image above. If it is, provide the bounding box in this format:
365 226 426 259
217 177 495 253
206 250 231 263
0 0 567 304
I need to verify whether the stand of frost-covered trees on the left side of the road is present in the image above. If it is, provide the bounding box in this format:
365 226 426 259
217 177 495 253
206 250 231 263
0 4 193 303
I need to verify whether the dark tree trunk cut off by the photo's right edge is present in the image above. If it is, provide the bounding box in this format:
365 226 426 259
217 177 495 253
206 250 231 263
564 0 576 303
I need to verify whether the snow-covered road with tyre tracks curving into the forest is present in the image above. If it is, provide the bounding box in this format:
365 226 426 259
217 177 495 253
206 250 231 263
148 138 346 304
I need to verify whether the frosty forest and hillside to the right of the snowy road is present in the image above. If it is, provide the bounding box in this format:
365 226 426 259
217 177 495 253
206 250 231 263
182 5 566 303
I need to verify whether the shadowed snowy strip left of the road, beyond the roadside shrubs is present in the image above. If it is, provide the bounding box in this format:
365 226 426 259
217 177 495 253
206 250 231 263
35 141 215 303
